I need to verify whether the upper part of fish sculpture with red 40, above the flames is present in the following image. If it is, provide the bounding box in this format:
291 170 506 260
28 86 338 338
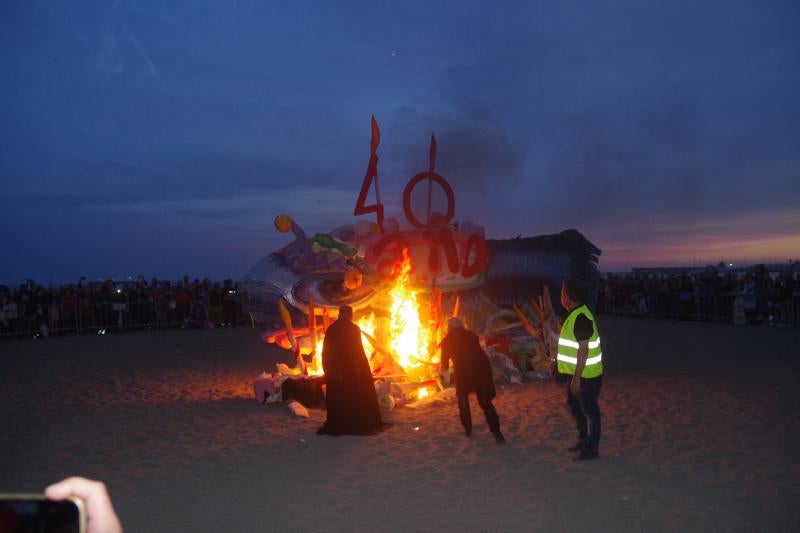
239 117 601 325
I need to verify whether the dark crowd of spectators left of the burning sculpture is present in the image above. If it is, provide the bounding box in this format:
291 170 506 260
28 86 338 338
0 276 243 338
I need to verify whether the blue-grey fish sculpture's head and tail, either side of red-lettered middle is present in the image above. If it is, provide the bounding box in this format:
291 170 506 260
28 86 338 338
238 222 602 324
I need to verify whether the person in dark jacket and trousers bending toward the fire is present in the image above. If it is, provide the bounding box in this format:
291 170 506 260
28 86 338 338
441 317 506 444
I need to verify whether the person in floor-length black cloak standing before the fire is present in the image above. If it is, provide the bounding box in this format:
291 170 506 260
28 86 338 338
317 305 386 435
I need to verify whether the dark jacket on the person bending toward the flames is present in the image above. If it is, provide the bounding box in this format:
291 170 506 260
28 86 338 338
442 328 495 400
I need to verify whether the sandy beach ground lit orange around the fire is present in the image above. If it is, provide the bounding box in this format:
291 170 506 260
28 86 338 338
0 316 800 532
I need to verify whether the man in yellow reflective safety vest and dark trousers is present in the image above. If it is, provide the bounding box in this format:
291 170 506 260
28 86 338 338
556 280 603 461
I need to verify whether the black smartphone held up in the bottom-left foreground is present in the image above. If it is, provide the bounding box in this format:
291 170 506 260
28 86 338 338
0 494 86 533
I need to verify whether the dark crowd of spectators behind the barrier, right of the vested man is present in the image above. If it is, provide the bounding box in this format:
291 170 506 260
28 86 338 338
597 265 800 327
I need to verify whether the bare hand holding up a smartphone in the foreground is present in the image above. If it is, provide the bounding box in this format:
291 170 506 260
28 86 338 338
44 477 122 533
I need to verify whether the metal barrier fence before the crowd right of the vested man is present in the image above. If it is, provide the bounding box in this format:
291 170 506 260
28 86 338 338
599 292 800 327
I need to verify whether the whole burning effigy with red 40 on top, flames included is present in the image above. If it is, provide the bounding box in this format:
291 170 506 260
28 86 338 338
244 117 601 410
